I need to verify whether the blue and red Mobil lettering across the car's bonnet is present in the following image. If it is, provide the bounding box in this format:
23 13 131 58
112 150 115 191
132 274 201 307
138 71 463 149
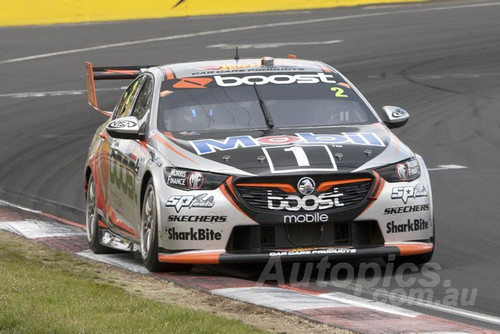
190 132 385 155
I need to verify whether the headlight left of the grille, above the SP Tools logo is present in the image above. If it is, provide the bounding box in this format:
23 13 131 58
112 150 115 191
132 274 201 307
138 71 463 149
163 167 227 190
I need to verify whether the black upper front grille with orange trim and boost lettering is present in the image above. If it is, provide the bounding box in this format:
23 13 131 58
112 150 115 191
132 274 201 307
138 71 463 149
235 178 373 212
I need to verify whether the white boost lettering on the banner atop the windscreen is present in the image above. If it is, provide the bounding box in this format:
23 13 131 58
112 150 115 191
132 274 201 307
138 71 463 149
214 73 337 87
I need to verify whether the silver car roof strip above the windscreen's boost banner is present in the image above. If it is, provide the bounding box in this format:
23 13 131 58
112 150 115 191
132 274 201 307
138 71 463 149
161 57 337 79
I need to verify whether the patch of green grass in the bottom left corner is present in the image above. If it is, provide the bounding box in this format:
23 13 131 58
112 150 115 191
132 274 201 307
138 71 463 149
0 232 268 333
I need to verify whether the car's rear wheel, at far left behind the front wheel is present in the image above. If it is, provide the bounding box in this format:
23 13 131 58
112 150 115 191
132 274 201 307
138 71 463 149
85 174 112 254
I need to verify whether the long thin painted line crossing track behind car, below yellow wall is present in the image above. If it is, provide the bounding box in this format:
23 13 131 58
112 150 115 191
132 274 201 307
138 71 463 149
0 2 500 65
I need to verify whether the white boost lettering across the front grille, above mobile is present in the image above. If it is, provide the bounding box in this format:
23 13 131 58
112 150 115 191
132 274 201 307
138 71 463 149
267 188 344 211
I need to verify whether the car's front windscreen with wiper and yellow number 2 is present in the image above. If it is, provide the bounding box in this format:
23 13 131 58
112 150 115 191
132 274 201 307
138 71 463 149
158 75 376 132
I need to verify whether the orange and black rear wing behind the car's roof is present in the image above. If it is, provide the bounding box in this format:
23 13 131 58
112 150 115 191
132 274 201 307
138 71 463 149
85 62 155 116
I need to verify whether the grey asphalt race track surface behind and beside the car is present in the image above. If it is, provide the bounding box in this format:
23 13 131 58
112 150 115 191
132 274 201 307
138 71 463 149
0 1 500 328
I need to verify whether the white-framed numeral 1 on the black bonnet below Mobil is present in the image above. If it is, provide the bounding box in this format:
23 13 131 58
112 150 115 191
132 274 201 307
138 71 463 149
262 145 337 173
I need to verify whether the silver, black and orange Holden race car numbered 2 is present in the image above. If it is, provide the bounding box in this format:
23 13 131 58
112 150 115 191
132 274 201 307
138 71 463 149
85 57 434 271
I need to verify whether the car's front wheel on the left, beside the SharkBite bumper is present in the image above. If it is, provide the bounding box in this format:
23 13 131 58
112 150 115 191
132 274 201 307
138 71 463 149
141 180 191 272
